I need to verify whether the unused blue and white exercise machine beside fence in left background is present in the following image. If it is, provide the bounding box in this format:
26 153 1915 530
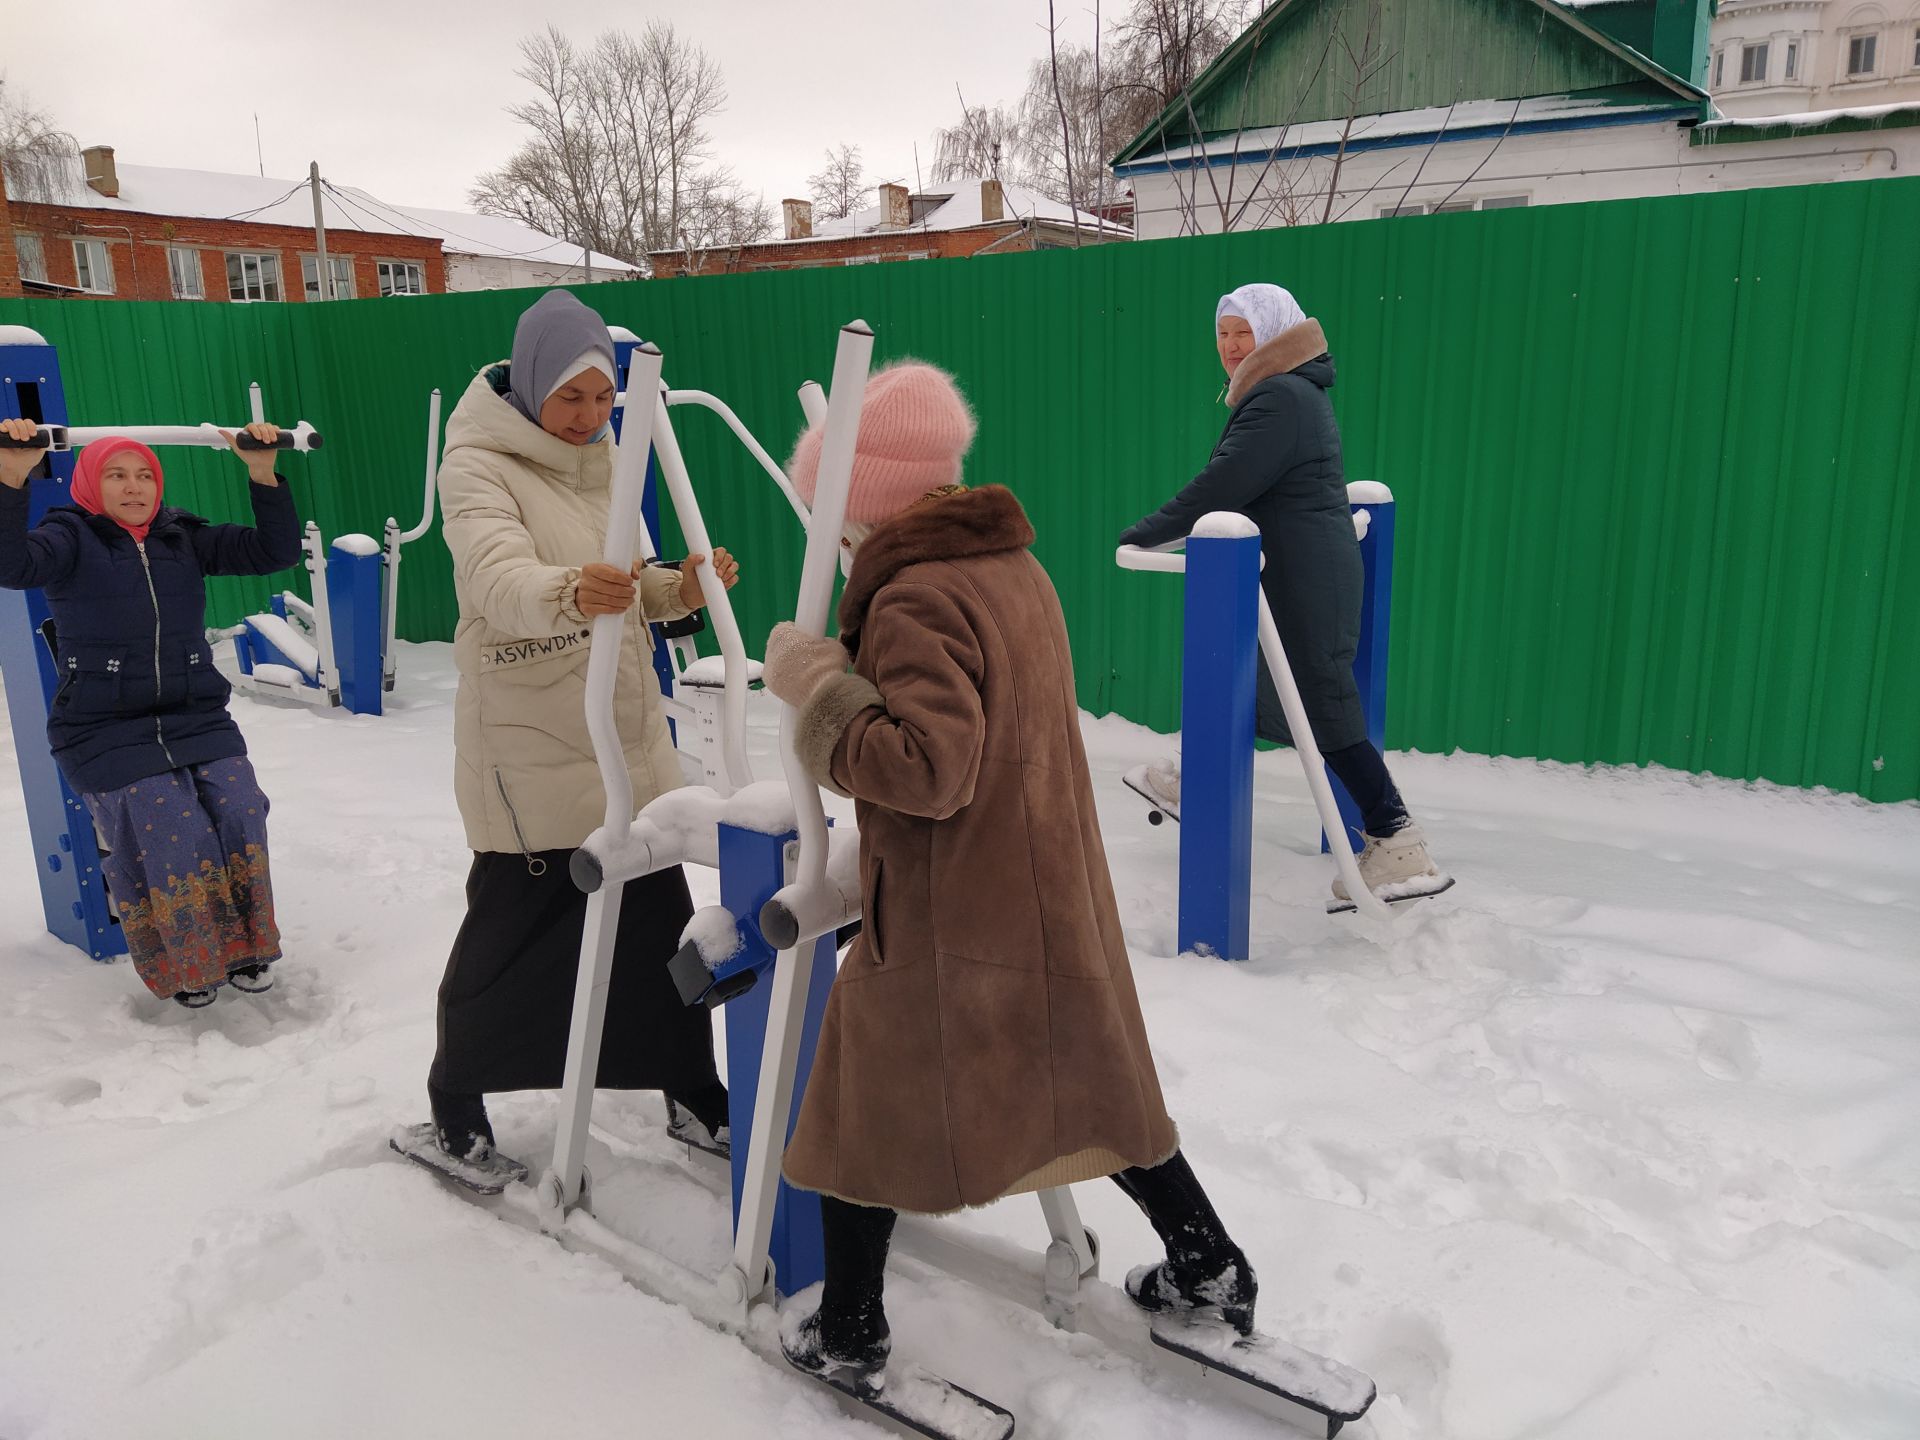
207 384 440 714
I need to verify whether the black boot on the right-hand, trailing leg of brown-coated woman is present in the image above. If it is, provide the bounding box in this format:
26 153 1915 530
1114 1150 1260 1334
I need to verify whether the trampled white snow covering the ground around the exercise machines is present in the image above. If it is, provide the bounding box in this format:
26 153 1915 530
0 645 1920 1440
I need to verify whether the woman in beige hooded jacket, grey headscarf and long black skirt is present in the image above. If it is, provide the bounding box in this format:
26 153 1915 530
426 290 737 1165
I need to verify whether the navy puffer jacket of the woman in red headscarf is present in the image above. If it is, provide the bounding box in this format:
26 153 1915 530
0 482 300 793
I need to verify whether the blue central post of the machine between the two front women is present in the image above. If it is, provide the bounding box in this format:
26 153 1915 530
720 826 835 1296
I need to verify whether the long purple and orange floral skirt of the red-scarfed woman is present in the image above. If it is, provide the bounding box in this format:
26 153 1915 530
83 755 280 996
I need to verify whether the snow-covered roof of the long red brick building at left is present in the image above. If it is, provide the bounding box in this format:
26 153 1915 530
18 163 637 273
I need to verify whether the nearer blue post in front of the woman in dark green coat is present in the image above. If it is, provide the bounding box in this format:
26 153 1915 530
1179 534 1260 960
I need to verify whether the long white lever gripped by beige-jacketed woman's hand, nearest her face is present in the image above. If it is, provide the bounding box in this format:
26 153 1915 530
553 346 660 1206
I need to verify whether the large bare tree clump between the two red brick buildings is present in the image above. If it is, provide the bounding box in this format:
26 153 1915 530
470 21 772 263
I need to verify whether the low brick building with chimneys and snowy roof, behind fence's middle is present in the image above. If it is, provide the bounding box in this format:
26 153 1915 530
647 180 1133 280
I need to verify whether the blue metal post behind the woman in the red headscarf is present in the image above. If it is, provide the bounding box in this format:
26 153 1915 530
0 330 127 960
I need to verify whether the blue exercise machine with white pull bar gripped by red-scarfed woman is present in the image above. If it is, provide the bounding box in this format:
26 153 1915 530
0 324 321 960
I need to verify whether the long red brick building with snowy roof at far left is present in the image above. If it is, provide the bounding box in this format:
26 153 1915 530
0 146 636 301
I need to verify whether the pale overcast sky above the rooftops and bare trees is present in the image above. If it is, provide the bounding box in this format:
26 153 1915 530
0 0 1092 209
